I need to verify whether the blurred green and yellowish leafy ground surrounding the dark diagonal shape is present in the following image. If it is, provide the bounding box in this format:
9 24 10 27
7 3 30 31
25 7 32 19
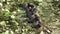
0 0 60 34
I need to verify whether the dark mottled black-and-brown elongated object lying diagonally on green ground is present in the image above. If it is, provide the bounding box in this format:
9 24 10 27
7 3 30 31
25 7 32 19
19 3 52 34
